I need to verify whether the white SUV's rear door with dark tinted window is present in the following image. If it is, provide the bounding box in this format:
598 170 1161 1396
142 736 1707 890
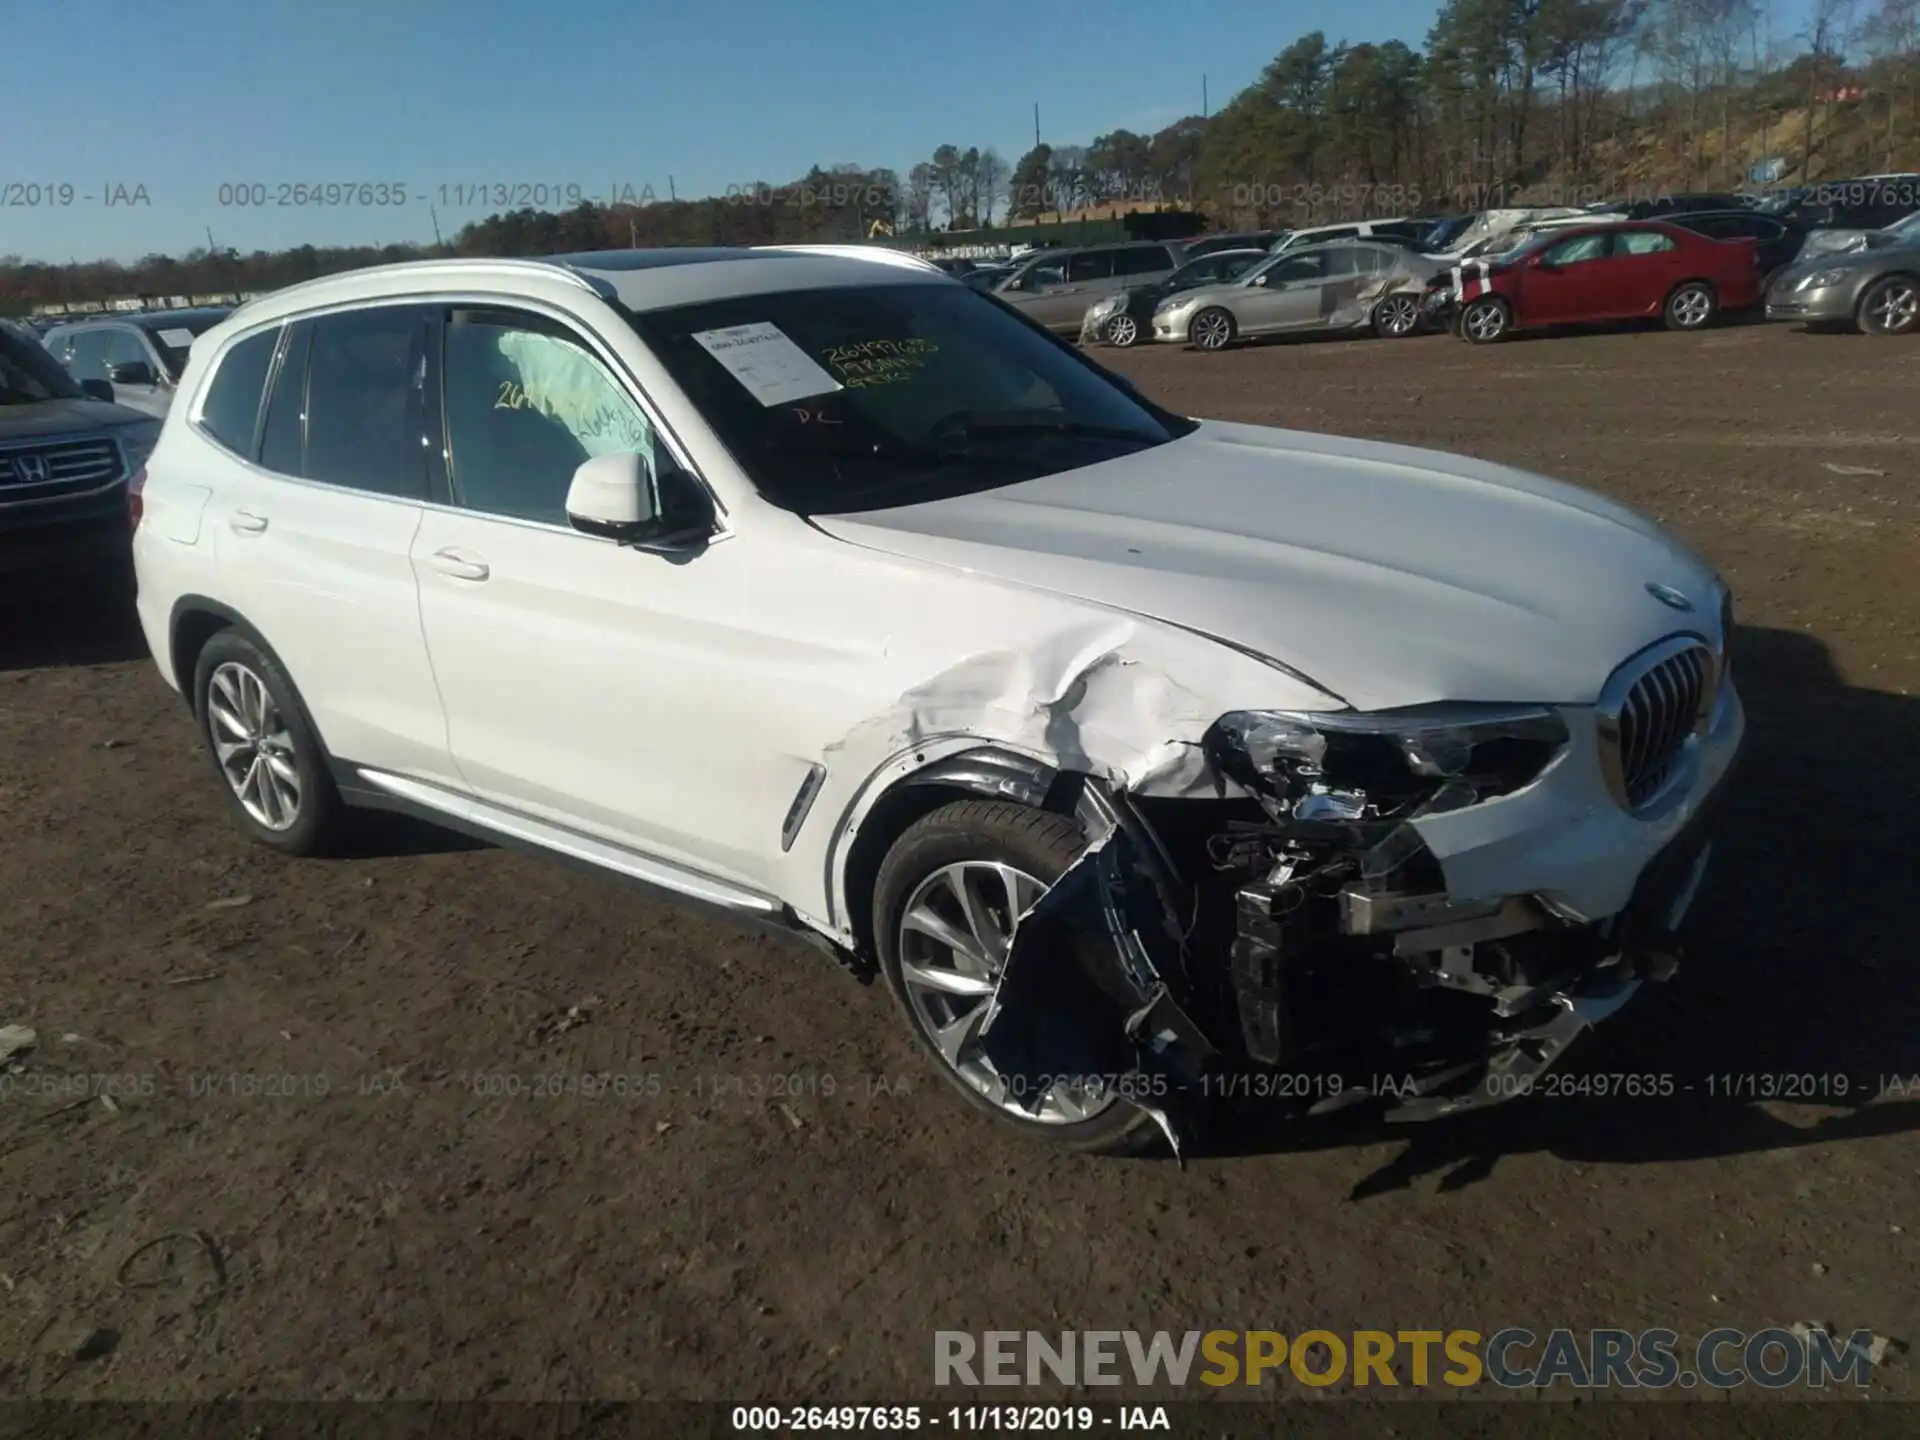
196 305 457 785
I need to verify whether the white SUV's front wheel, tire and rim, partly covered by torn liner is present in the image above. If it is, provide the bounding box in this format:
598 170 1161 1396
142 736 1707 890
874 801 1158 1154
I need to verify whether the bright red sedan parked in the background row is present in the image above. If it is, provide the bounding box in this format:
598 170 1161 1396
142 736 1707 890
1427 221 1761 346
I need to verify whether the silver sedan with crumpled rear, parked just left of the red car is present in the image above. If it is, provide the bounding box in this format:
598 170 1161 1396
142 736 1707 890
1154 240 1438 349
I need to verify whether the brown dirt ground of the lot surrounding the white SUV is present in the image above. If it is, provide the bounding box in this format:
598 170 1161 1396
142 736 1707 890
0 326 1920 1402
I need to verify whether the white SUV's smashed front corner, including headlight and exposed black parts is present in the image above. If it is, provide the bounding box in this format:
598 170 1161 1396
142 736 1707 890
981 705 1707 1148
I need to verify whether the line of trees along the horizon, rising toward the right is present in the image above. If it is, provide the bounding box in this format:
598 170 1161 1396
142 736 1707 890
0 0 1920 305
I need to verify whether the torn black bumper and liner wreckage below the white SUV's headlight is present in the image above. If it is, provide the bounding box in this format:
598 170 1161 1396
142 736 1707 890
981 695 1726 1152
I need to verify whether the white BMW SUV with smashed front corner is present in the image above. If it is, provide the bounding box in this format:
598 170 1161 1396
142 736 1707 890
132 248 1743 1150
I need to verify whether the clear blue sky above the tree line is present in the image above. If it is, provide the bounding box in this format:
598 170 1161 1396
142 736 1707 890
0 0 1803 261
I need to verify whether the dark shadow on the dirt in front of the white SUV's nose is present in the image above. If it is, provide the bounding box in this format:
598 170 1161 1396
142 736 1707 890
1208 630 1920 1198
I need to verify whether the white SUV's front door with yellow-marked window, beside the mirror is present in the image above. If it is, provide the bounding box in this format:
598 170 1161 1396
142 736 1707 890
413 309 808 889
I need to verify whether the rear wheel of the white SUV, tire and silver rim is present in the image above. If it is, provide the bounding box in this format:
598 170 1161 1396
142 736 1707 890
194 630 346 854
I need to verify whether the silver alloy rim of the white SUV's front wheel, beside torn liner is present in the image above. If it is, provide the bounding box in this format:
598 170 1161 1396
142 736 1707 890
897 860 1116 1125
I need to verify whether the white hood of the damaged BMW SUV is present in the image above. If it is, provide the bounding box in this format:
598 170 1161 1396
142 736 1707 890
818 422 1718 710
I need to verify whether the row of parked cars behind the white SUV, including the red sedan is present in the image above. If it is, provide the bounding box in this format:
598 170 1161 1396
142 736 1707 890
1059 196 1920 349
